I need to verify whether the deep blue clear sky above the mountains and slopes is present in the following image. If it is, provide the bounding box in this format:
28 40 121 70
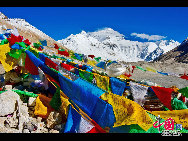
0 7 188 42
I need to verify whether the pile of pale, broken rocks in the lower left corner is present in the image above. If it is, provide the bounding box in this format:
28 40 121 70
0 90 64 133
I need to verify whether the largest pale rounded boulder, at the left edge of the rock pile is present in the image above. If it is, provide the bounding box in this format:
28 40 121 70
0 90 20 116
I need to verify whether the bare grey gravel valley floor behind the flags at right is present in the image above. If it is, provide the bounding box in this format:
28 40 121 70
126 62 188 89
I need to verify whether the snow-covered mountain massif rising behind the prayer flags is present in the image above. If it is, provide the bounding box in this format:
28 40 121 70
58 28 180 62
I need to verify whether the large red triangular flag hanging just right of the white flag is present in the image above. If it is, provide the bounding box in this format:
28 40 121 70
151 86 174 110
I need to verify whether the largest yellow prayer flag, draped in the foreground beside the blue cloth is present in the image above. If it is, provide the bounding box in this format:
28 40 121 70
101 93 153 131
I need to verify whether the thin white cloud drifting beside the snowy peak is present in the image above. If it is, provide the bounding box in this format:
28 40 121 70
131 33 166 41
